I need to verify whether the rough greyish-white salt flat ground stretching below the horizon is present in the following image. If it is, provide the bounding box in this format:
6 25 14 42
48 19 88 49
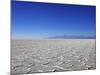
11 39 96 75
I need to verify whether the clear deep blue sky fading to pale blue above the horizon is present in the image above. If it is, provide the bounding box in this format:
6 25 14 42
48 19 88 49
11 1 96 38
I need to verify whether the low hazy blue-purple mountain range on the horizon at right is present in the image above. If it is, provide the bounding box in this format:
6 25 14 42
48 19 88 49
48 35 96 39
